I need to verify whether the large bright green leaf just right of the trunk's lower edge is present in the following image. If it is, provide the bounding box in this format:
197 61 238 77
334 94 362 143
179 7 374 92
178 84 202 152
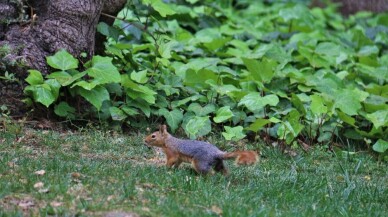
86 56 121 84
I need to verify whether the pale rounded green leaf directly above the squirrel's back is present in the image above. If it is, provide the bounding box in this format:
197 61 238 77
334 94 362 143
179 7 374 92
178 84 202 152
185 116 211 139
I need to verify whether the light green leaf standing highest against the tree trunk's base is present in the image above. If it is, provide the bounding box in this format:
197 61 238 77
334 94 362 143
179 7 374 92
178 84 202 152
46 50 78 71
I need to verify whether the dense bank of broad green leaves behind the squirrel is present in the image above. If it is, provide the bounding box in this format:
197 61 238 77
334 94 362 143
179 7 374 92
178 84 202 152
26 0 388 156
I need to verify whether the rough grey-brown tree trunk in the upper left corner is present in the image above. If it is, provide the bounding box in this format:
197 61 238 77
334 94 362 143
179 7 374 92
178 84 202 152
0 0 126 116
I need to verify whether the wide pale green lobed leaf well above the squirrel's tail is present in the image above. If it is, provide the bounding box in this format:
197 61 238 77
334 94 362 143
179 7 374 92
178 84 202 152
238 92 279 112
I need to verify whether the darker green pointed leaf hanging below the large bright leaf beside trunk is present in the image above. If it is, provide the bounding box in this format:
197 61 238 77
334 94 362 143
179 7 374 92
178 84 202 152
78 86 110 111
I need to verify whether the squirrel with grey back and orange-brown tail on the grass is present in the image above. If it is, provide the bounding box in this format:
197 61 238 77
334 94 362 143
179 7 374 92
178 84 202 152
144 125 259 175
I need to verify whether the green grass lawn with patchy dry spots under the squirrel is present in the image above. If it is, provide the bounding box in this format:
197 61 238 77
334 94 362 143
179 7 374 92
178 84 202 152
0 130 388 216
